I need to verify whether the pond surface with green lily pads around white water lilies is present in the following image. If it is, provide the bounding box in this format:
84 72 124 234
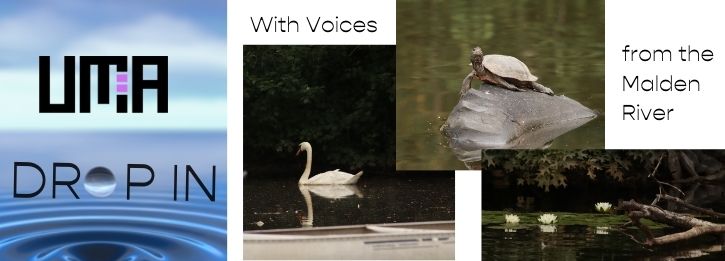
482 211 725 260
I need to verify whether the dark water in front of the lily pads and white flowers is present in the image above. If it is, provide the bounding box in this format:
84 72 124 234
482 222 725 260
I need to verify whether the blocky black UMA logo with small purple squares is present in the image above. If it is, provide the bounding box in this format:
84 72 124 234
39 56 169 113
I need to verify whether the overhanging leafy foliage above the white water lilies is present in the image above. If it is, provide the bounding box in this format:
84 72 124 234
481 150 662 191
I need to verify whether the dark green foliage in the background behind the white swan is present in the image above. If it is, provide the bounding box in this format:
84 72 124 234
243 46 395 169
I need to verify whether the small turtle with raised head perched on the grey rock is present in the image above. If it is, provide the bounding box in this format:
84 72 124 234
461 47 554 96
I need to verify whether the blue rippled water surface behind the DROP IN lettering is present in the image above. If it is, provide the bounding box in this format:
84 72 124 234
0 132 226 261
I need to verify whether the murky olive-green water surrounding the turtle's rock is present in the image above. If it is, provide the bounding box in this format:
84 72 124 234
396 0 604 170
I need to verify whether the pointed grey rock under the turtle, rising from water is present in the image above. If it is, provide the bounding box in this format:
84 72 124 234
441 84 597 156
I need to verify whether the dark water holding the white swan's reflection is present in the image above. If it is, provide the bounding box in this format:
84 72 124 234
244 172 455 230
